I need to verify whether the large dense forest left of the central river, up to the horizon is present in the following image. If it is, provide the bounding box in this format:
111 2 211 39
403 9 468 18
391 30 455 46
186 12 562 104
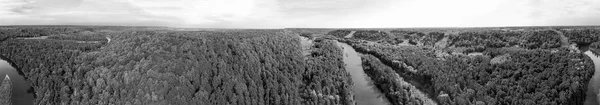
0 27 353 105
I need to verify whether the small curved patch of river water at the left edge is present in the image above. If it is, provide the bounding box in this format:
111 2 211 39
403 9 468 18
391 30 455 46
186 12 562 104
0 59 33 105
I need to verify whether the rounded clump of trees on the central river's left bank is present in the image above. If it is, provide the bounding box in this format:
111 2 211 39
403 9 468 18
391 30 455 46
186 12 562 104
302 39 354 105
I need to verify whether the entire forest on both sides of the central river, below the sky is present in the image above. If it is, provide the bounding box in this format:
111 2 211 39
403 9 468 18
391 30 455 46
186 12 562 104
0 26 600 105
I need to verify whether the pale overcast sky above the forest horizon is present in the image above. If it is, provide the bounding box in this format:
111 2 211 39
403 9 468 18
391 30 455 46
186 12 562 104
0 0 600 28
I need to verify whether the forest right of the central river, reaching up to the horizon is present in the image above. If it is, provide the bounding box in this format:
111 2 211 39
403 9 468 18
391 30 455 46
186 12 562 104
334 29 600 105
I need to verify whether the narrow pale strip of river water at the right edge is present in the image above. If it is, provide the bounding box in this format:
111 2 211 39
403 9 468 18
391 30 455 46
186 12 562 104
584 51 600 105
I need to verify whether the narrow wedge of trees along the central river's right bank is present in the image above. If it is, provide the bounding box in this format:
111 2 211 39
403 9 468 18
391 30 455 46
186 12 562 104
338 39 437 105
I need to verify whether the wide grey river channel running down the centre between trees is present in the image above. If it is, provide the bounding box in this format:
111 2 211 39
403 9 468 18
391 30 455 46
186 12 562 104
338 42 388 105
